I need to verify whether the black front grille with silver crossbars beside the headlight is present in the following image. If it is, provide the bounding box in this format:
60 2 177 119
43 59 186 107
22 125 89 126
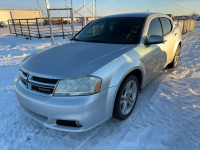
19 71 58 96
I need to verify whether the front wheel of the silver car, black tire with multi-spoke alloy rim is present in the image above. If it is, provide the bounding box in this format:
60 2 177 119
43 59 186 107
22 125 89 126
113 75 139 120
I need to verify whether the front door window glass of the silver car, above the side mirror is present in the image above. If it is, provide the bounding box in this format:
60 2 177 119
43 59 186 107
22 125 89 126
147 18 163 38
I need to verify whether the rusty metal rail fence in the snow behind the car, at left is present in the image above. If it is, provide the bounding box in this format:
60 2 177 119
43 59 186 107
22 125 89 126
8 17 83 39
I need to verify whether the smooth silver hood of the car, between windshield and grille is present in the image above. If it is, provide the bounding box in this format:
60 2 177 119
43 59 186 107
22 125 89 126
20 42 135 79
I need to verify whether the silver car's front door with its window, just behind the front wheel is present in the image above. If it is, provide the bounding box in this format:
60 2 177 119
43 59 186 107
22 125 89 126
145 18 167 81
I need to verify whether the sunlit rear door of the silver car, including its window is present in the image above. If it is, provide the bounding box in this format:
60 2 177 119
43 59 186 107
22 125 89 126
160 17 176 64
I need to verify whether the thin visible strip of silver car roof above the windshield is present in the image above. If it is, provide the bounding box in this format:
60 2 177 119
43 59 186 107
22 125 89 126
101 12 166 18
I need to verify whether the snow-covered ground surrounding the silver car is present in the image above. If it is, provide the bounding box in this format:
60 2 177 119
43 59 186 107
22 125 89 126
0 22 200 150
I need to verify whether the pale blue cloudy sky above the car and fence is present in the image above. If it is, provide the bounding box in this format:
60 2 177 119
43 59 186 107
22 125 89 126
0 0 200 17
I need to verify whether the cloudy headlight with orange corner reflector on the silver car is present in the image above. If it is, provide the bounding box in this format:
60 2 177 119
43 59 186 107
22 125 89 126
54 76 101 96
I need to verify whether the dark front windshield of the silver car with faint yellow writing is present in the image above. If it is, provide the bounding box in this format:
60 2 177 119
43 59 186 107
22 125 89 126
72 17 144 44
